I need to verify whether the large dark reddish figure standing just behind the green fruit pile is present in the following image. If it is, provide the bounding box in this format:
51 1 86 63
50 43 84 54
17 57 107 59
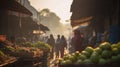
72 30 84 51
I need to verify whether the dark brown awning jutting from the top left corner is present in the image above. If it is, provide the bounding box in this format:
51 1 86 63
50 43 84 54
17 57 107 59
0 0 32 15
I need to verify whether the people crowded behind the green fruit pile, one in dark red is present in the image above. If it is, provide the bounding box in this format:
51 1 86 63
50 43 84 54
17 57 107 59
70 29 109 52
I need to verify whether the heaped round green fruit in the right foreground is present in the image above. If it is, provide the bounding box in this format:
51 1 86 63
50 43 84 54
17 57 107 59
59 42 120 65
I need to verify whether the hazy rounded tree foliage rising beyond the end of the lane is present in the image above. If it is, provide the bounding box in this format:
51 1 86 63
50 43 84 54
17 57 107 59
39 9 63 34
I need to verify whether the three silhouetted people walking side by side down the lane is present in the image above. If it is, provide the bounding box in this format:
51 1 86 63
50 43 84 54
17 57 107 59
46 34 67 58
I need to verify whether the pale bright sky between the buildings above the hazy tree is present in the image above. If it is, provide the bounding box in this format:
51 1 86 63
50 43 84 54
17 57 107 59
29 0 73 23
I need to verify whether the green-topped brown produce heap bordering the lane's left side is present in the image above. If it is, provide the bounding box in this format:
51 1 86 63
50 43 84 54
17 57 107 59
10 42 50 67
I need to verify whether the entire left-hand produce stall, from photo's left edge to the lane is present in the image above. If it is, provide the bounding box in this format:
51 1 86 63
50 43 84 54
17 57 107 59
0 41 51 67
